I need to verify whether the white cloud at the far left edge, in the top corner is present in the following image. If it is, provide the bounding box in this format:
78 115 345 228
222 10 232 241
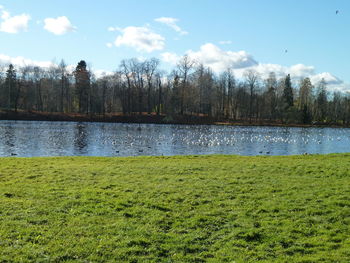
0 6 30 34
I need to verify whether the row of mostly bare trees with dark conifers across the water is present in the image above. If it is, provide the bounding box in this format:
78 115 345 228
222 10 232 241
0 56 350 125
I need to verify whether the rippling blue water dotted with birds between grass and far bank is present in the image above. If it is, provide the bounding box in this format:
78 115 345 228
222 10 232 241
0 121 350 156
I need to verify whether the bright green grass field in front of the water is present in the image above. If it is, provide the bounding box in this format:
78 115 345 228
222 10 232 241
0 154 350 263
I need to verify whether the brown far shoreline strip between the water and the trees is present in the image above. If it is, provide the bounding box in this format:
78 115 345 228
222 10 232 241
0 111 350 128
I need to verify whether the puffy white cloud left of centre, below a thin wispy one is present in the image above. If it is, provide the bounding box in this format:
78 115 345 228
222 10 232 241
114 26 165 53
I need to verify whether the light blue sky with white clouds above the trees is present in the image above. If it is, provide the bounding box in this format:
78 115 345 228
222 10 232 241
0 0 350 91
